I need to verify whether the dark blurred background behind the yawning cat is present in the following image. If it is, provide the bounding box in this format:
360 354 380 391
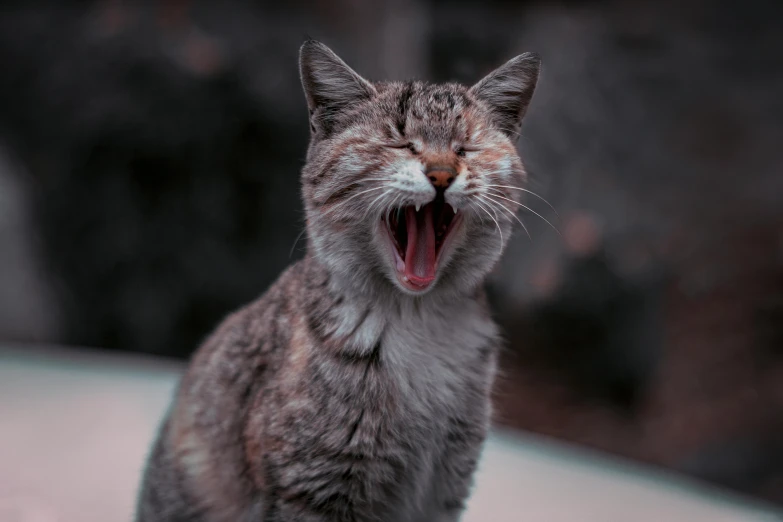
0 0 783 505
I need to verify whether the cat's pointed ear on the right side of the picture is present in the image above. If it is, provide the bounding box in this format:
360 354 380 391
470 53 541 139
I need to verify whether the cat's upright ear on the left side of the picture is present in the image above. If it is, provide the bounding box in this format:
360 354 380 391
299 40 375 135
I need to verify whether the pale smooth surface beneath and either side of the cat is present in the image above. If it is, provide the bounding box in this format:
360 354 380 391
0 348 783 522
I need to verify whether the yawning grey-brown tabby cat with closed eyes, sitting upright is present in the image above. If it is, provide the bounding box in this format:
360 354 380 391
136 40 540 522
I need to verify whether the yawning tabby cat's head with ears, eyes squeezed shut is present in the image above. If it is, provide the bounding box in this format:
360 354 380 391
300 41 540 295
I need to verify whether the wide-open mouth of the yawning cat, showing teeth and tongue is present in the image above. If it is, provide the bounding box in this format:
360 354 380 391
383 195 462 292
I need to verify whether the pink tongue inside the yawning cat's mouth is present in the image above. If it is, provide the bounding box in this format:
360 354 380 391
405 203 436 286
